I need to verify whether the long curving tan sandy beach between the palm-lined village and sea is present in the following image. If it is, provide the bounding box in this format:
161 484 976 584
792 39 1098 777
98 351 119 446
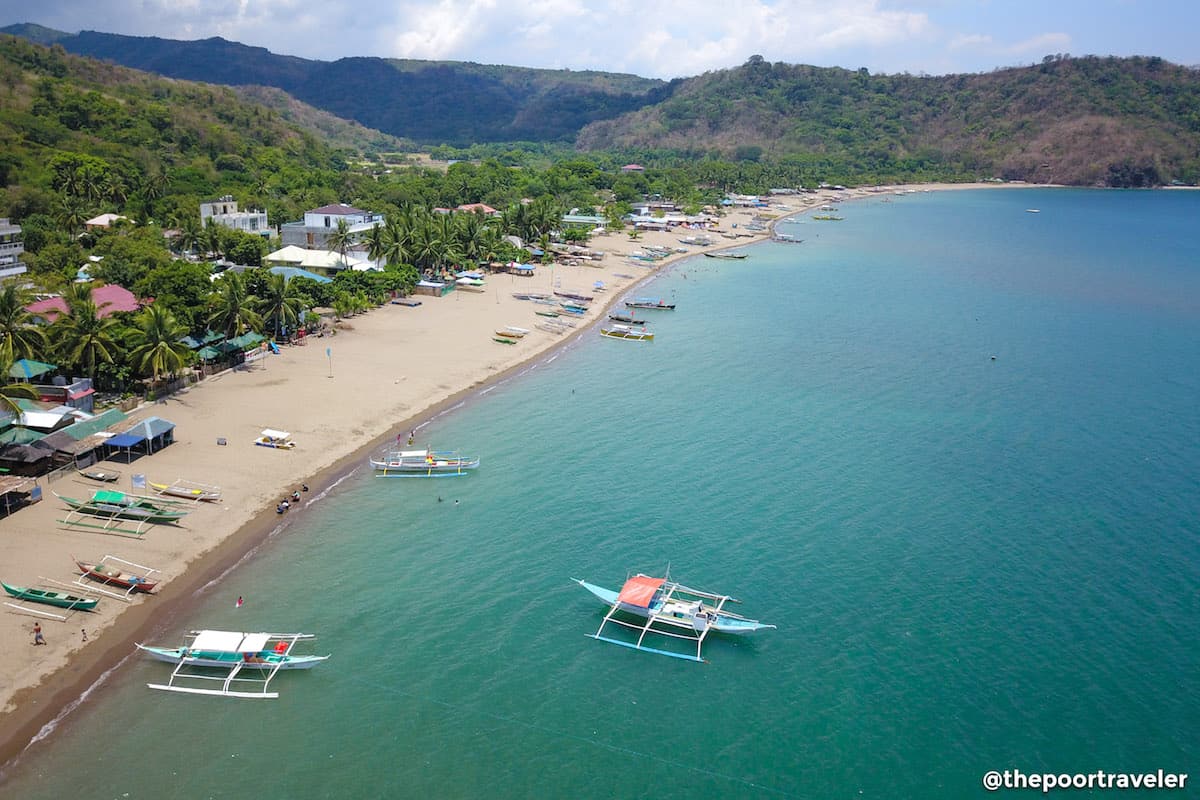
0 184 998 764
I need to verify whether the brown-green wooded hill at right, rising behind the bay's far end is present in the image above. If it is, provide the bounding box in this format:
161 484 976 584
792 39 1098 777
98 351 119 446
578 56 1200 186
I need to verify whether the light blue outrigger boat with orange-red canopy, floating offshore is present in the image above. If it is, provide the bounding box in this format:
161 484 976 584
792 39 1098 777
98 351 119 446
571 573 775 662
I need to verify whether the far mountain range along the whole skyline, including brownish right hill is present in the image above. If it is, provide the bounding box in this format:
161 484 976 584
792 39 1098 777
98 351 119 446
2 25 1200 186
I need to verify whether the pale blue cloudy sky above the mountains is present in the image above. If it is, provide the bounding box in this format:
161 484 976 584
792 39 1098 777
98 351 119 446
0 0 1200 78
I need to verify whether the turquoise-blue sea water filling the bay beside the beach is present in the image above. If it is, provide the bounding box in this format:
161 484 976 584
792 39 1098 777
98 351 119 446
0 190 1200 799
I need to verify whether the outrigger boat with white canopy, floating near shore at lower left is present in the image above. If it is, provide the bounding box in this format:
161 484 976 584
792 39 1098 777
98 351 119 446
138 631 329 699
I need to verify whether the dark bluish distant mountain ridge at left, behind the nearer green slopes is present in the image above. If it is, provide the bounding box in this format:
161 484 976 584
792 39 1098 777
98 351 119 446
0 25 670 145
